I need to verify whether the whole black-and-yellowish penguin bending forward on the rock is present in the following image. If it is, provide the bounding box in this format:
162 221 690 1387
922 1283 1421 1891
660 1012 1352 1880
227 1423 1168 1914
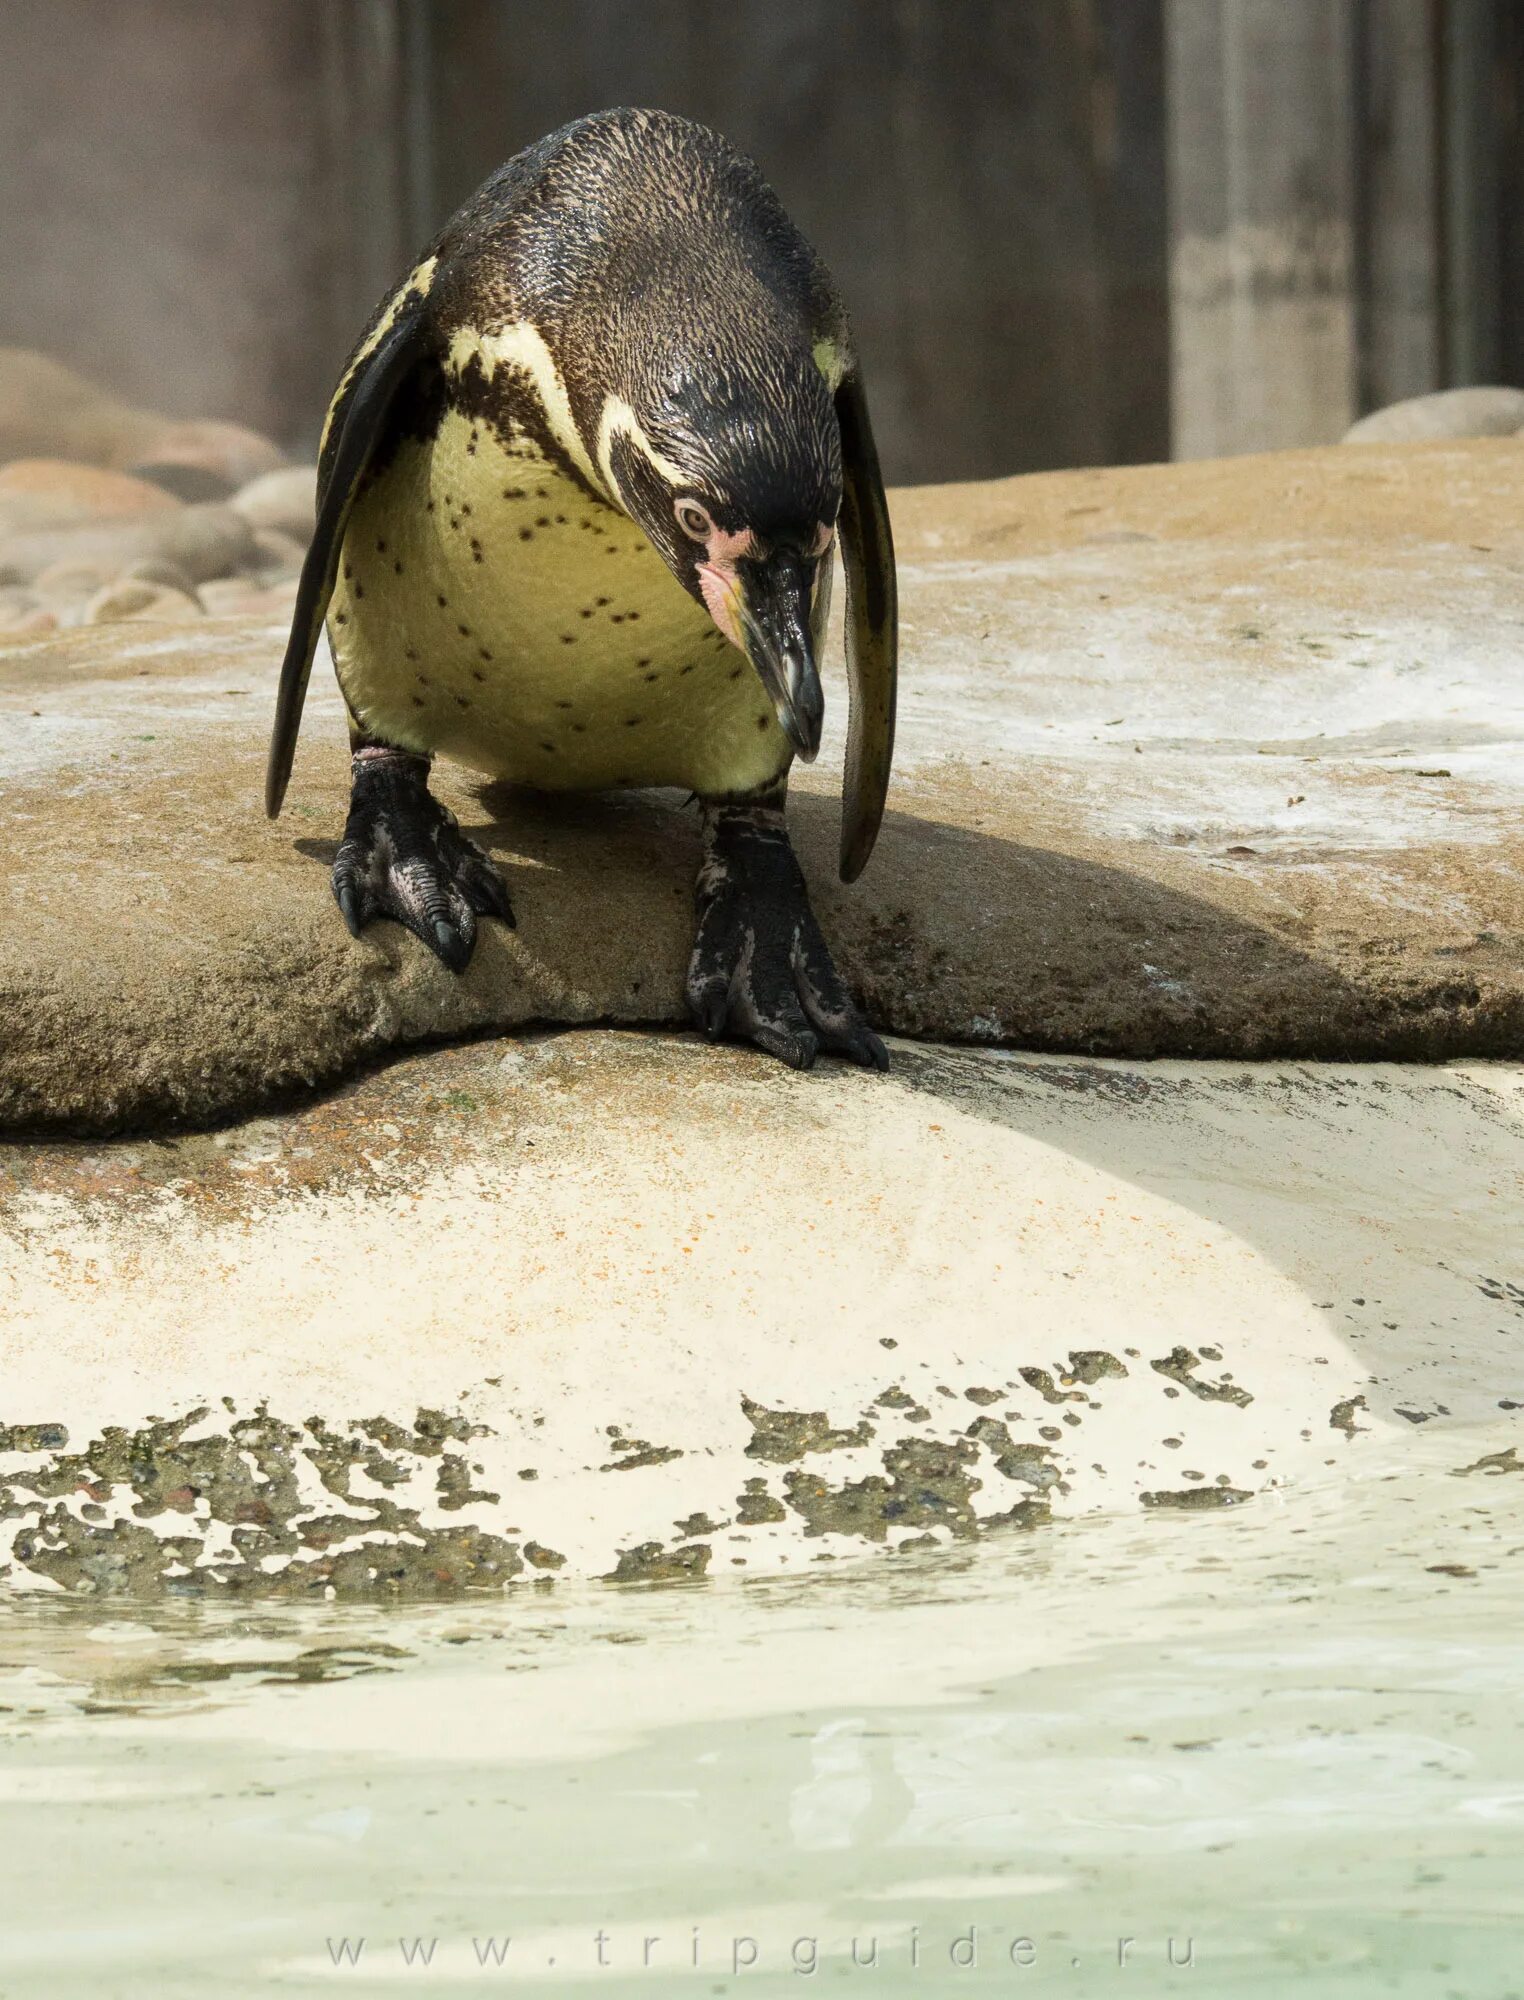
266 110 896 1068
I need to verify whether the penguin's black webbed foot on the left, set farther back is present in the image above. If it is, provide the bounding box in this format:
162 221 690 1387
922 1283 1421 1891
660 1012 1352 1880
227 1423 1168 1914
334 746 514 972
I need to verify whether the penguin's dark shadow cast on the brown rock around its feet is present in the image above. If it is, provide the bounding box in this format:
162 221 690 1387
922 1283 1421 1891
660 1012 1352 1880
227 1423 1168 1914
282 778 1392 1058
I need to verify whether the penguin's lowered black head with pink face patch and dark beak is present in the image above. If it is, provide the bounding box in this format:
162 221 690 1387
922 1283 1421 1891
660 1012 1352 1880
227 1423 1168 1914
604 354 842 764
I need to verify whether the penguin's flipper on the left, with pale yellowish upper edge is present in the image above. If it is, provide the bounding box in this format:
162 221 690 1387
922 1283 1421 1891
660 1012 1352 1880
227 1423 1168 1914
264 292 432 820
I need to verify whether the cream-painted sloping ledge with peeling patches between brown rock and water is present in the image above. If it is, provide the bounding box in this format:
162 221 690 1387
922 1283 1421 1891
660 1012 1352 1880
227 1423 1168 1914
0 1032 1524 1596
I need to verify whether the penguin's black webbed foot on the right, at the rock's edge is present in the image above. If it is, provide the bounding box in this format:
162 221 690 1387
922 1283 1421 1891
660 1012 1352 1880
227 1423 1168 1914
688 806 888 1070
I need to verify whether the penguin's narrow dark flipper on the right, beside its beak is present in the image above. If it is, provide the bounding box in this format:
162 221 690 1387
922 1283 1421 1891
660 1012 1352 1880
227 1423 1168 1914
836 374 900 882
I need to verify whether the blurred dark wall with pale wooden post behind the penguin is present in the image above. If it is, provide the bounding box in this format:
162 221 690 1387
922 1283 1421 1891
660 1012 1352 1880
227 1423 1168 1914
0 0 1524 480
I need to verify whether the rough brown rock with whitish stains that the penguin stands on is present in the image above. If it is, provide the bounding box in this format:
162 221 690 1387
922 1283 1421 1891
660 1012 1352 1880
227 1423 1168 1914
0 442 1524 1132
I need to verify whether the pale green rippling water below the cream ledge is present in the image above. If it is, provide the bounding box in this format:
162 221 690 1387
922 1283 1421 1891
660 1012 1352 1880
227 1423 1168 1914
0 1440 1524 2000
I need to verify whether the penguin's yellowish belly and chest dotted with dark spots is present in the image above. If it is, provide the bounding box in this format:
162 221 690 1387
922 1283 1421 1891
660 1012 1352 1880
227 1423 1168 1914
328 408 790 796
